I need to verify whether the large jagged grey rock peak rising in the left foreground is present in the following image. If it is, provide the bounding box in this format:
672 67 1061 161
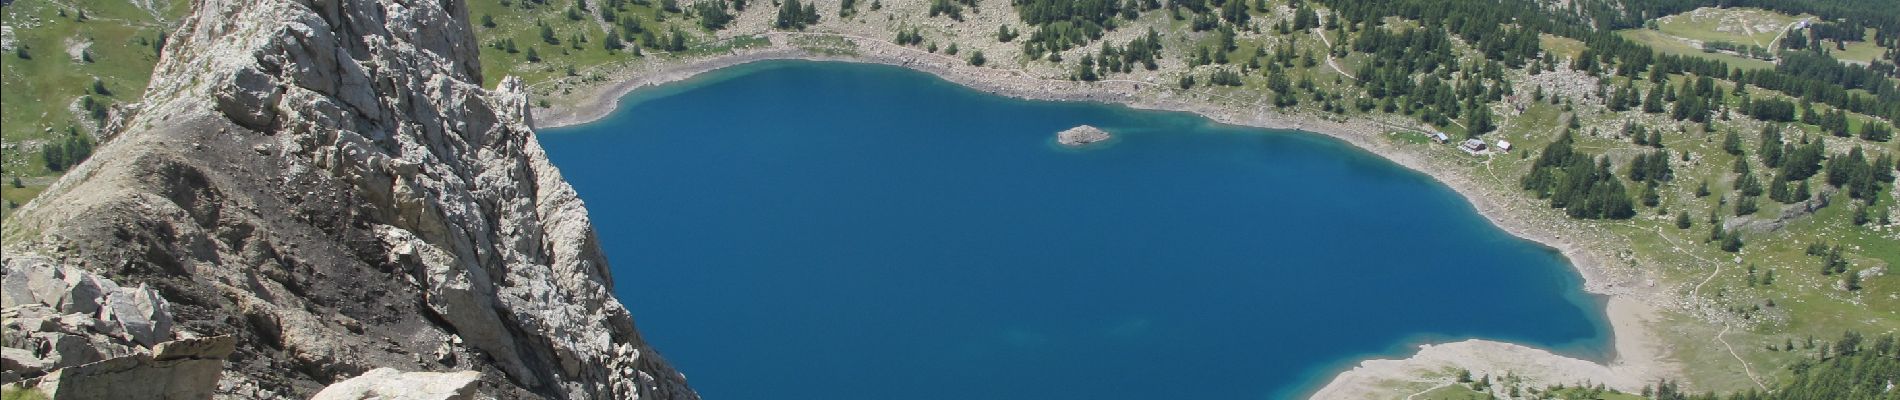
6 0 697 398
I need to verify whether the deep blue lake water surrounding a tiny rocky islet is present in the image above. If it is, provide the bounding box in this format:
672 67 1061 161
542 61 1609 400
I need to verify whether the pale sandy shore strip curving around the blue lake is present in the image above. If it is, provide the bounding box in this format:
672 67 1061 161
534 32 1680 398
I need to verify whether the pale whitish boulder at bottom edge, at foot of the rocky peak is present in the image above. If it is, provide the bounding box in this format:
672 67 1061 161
310 368 481 400
